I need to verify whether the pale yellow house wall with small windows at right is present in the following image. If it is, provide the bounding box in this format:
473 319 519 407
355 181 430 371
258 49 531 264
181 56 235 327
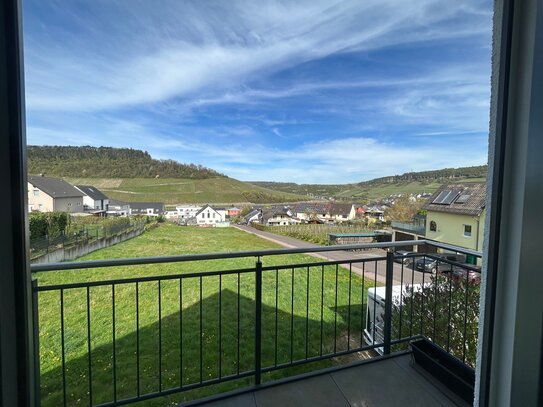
426 211 485 251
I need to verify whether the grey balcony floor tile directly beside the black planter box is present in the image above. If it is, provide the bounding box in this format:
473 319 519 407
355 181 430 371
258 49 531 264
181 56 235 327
332 359 450 407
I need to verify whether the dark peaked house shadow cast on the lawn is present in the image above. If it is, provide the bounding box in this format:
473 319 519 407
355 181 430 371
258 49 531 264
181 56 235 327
41 289 364 406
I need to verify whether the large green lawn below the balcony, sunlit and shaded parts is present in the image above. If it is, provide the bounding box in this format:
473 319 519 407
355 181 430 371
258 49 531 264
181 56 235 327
39 224 380 406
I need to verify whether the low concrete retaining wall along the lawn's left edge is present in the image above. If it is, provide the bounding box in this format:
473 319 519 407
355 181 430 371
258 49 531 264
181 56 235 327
31 228 144 263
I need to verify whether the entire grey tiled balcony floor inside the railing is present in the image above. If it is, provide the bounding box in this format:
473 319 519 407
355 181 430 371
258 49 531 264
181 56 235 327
197 354 468 407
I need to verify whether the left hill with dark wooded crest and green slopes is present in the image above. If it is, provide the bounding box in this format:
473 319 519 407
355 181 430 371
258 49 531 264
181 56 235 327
28 146 304 204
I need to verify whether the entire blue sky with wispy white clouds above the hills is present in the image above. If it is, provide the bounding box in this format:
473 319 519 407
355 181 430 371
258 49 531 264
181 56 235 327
23 0 492 184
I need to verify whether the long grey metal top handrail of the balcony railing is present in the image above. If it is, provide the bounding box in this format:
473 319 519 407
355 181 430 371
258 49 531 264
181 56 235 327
30 239 482 273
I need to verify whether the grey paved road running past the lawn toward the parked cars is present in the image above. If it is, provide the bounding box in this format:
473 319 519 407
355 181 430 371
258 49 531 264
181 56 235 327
234 225 430 285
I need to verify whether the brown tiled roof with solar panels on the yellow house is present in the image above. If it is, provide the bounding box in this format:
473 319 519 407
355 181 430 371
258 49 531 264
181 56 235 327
422 182 486 216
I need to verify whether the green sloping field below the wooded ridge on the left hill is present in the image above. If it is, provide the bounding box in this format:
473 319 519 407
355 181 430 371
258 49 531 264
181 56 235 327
65 177 305 204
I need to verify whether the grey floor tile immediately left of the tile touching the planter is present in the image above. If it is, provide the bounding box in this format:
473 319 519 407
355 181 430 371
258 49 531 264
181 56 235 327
255 375 349 407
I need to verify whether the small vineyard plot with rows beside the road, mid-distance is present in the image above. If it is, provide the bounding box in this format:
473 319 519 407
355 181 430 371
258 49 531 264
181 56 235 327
257 224 372 245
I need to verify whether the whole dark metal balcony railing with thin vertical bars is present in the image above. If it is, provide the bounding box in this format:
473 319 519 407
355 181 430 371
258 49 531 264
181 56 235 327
32 240 480 406
